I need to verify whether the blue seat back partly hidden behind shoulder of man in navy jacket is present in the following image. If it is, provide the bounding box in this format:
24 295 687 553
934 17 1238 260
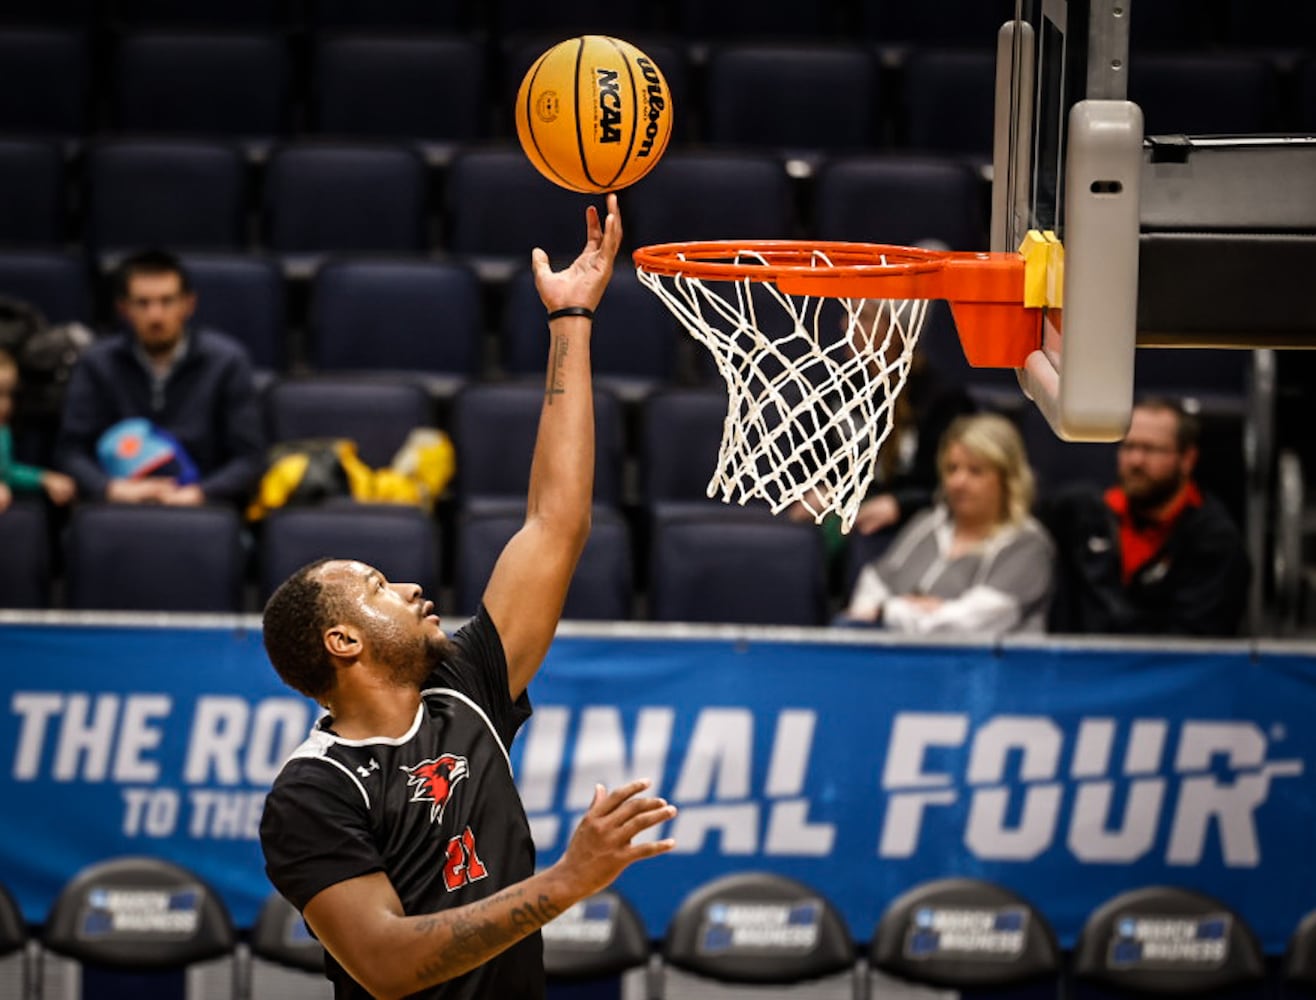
183 254 288 372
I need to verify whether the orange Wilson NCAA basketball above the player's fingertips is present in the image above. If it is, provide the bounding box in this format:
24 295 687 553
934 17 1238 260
516 34 671 193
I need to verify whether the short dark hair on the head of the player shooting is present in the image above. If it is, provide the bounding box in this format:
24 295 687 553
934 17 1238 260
261 559 341 704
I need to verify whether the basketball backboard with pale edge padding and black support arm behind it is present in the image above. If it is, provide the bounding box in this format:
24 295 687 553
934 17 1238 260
991 0 1316 441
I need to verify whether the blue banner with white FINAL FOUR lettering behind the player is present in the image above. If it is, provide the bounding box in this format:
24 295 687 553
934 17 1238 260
0 625 1316 951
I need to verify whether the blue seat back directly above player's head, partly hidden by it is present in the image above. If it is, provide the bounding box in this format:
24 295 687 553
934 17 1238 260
261 503 440 603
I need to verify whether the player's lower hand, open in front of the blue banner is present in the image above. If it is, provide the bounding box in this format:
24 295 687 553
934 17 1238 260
554 780 676 899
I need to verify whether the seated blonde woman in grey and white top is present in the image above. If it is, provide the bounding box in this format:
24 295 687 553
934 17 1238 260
838 413 1054 634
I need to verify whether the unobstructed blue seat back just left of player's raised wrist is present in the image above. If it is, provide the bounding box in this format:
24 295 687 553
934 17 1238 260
311 261 483 389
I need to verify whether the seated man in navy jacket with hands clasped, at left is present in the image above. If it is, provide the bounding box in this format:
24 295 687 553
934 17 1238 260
55 250 265 505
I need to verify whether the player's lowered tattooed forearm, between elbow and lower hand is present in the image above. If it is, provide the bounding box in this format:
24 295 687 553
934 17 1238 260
376 868 580 997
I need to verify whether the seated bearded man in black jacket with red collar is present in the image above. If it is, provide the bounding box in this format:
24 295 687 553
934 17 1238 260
1041 399 1249 636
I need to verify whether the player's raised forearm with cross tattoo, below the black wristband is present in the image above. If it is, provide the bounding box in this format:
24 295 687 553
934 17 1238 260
526 316 594 533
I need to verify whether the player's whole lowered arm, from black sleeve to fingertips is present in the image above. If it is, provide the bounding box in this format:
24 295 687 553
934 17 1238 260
303 782 676 1000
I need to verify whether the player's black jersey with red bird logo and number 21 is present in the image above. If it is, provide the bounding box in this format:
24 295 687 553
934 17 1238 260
261 608 544 1000
